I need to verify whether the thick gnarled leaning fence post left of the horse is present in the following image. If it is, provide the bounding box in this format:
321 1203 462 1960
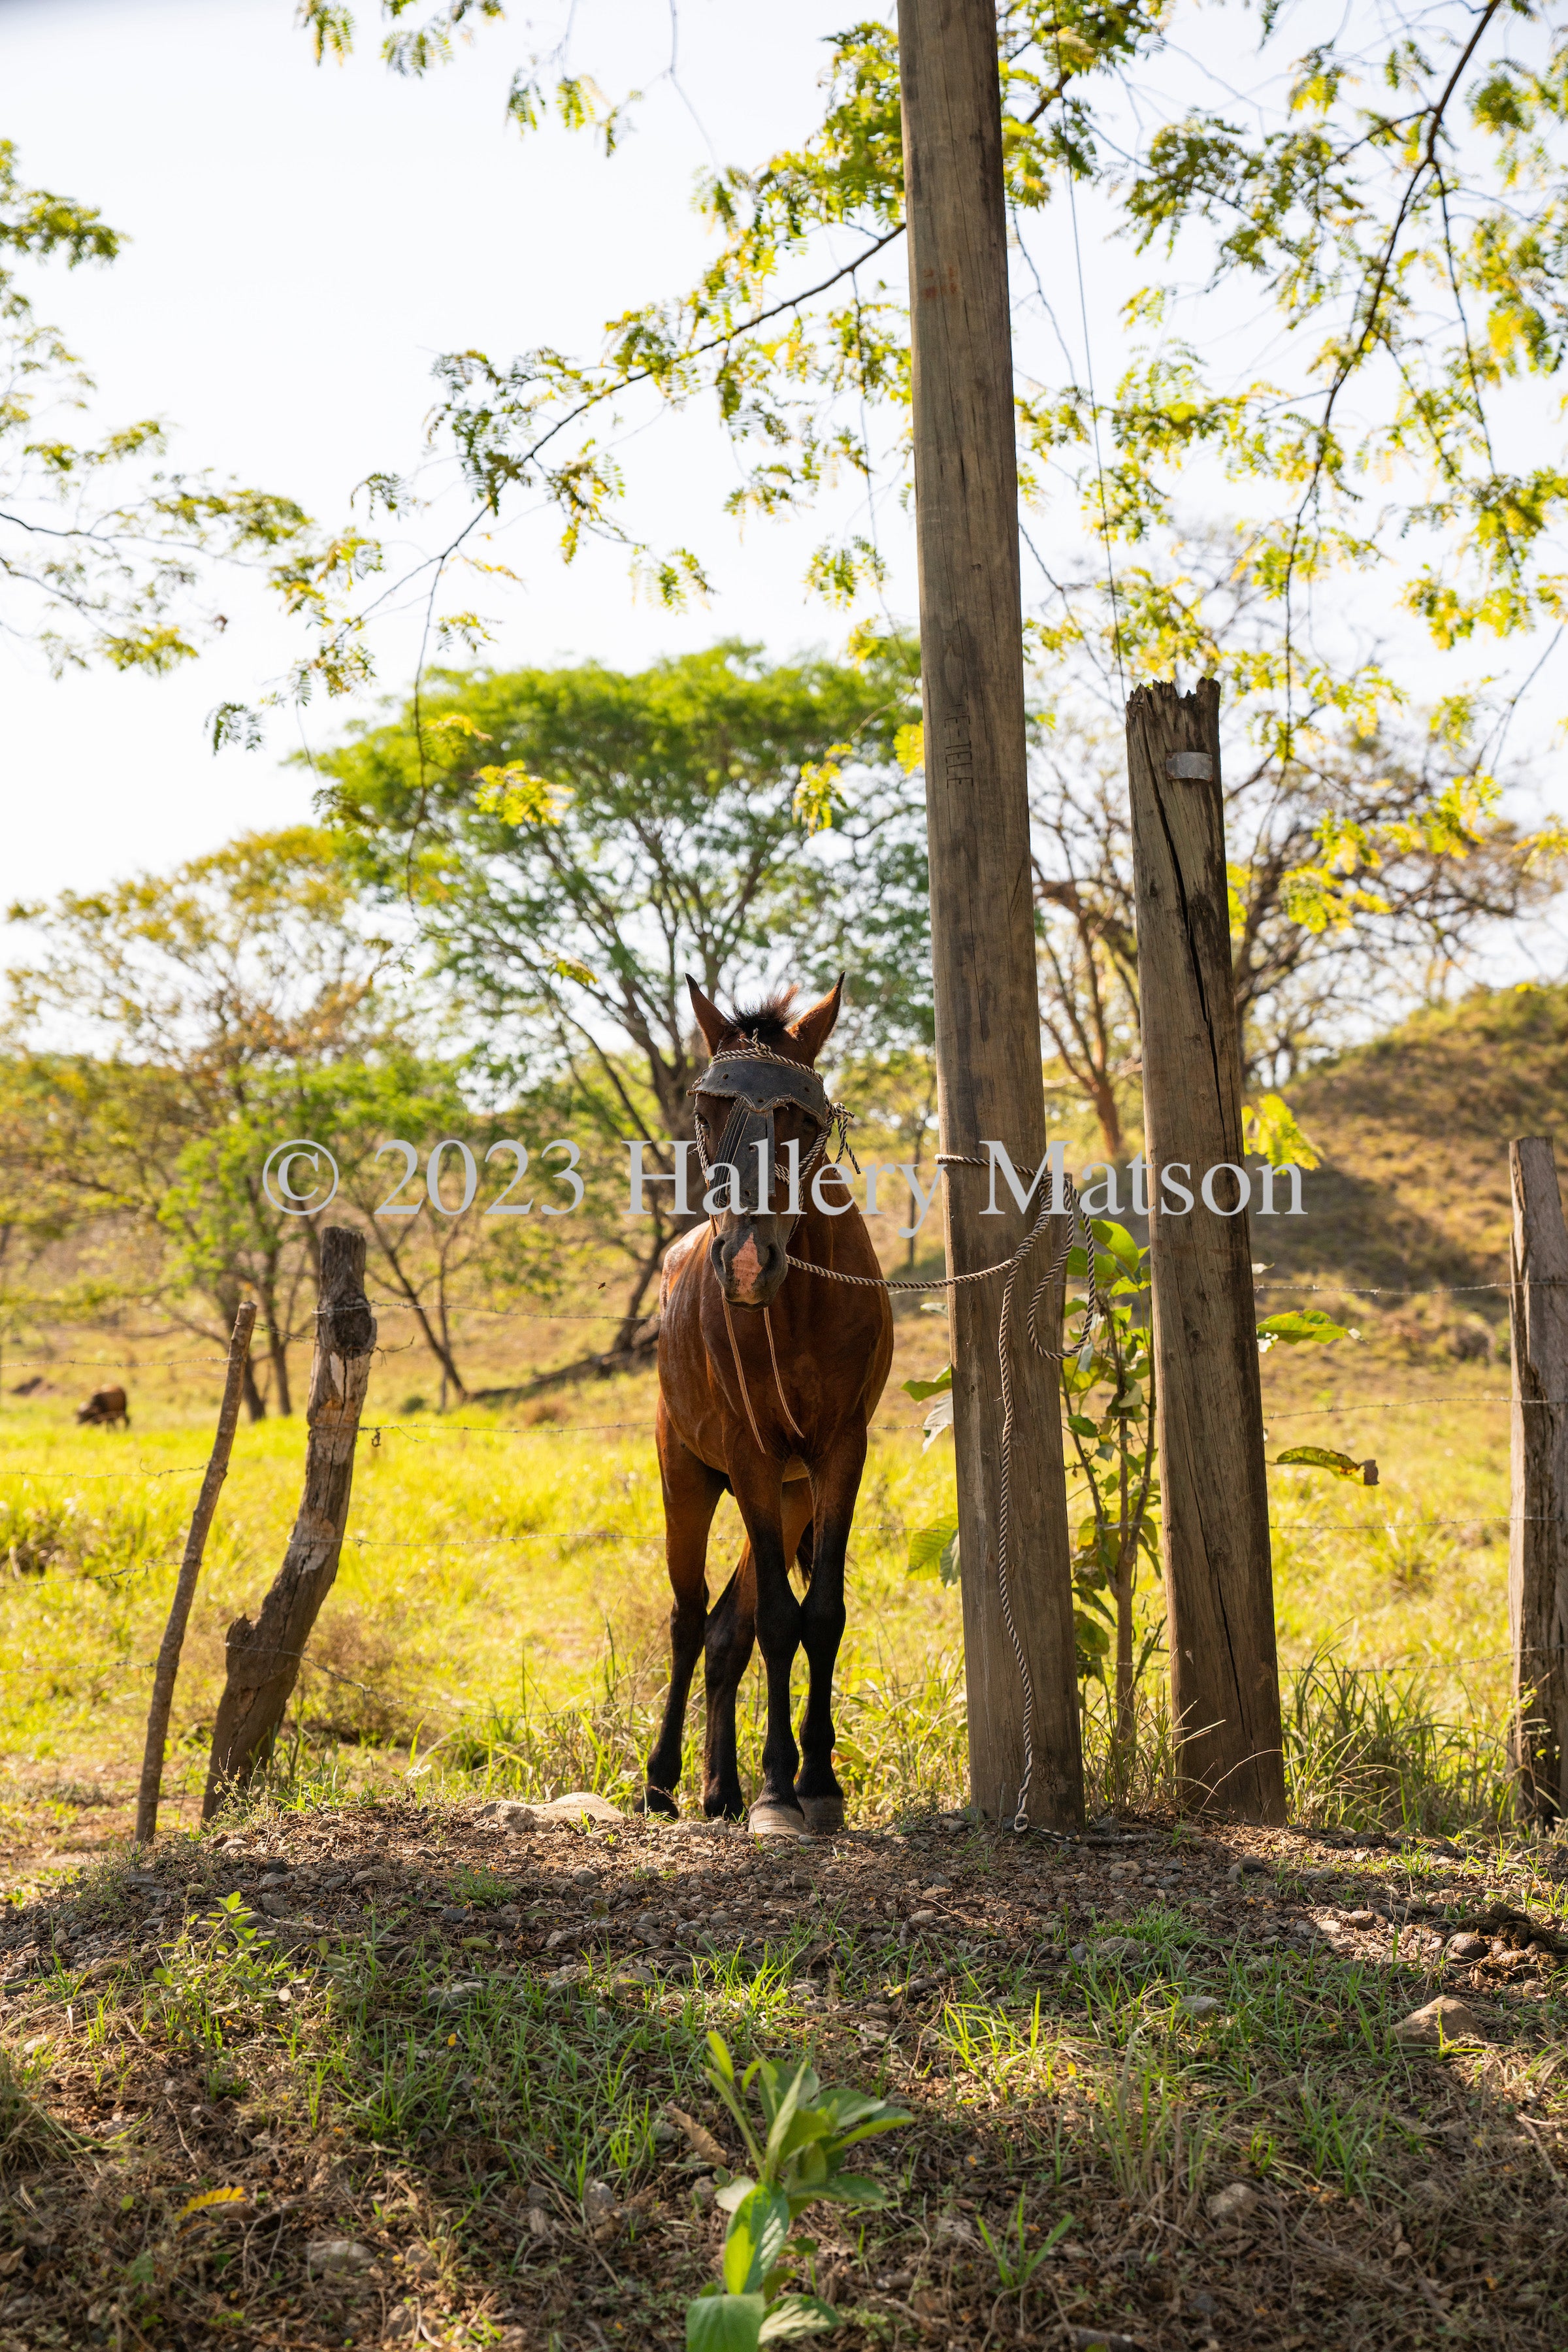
202 1226 376 1820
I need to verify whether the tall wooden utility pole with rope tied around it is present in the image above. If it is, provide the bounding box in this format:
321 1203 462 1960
898 0 1084 1827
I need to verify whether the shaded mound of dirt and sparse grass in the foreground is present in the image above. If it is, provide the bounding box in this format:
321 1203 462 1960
0 1795 1568 2352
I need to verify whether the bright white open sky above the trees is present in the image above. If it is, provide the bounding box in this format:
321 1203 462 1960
0 0 1561 978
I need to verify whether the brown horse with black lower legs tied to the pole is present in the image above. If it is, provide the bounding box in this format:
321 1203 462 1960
644 979 893 1835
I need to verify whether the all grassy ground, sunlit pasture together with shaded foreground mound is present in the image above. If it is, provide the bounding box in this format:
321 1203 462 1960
0 1301 1568 2352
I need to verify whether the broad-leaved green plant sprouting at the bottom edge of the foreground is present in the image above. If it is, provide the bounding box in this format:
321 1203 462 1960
687 2034 912 2352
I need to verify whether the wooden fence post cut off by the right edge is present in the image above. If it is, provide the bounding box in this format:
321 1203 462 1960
1509 1136 1568 1823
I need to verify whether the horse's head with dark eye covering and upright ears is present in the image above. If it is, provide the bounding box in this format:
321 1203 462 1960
687 976 844 1308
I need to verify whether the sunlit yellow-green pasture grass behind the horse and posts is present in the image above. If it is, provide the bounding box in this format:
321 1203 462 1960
0 1317 1507 1830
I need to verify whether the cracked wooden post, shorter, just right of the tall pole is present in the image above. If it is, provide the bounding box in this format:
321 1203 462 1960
1126 678 1286 1823
